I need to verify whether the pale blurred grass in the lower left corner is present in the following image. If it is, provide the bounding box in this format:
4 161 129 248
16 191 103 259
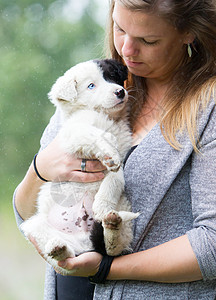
0 200 45 300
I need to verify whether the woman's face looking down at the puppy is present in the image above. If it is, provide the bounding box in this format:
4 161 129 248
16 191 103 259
113 2 190 81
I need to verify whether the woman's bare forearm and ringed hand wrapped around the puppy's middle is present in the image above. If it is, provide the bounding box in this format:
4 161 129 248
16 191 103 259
15 135 106 220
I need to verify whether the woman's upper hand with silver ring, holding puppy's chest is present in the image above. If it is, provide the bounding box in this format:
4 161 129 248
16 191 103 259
37 135 106 182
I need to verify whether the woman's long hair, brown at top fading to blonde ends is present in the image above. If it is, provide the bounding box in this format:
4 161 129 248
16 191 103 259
107 0 216 150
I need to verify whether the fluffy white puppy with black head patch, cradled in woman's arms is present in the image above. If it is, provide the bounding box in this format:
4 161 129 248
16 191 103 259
21 59 138 275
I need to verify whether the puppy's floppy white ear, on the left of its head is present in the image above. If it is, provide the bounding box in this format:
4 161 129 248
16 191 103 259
48 68 77 105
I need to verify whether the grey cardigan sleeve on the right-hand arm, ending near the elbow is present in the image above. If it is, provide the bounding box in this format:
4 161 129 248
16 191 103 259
187 104 216 280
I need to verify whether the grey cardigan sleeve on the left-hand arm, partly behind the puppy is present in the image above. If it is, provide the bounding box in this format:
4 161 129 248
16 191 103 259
13 109 62 227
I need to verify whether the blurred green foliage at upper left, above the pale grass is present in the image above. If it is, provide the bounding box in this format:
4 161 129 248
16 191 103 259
0 0 106 205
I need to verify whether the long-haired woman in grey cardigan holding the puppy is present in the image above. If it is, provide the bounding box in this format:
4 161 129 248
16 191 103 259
15 0 216 299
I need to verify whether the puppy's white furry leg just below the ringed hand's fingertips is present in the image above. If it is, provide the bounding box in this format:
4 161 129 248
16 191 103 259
92 168 124 221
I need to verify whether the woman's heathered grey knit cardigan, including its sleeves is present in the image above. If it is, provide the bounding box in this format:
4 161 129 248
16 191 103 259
15 100 216 300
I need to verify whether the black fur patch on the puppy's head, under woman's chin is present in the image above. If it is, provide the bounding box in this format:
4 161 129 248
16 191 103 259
94 59 128 86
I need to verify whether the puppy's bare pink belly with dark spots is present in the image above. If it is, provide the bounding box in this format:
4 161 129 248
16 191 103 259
48 199 93 234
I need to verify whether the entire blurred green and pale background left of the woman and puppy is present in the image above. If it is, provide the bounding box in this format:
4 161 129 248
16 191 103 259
0 0 108 300
